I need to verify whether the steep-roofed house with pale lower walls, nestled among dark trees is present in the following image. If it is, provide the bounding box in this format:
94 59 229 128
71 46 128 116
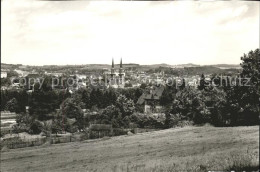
137 86 164 113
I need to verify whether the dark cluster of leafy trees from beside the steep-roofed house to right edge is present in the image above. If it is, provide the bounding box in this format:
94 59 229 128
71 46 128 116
167 49 260 126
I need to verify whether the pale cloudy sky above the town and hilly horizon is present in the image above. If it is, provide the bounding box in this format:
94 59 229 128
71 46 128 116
1 0 260 65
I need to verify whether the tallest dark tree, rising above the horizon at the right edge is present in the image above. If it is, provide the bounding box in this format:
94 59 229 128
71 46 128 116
237 49 260 125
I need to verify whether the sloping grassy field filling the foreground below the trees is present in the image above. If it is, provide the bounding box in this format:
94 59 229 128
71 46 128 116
1 126 259 172
